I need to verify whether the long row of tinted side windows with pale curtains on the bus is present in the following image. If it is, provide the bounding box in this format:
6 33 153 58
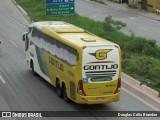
32 29 77 66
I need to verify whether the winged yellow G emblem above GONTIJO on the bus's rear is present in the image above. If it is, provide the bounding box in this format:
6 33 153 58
89 49 112 60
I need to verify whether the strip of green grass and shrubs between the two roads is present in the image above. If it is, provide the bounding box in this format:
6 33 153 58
16 0 160 93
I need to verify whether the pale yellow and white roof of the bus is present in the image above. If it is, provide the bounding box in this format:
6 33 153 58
32 21 115 47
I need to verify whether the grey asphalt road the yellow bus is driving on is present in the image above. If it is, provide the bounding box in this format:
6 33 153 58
0 0 158 120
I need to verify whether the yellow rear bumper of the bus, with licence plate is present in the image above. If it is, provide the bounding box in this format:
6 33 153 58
77 93 120 104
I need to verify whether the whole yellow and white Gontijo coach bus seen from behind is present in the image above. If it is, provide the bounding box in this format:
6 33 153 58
22 21 121 104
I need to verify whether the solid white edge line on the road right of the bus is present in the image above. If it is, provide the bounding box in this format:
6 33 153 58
122 87 160 111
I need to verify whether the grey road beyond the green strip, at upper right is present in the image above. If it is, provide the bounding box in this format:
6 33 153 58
75 0 160 46
